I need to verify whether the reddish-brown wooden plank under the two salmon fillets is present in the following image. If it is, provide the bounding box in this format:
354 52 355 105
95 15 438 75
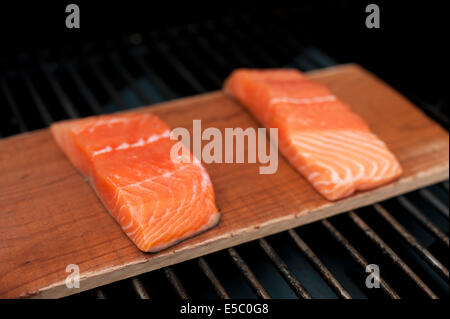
0 65 449 298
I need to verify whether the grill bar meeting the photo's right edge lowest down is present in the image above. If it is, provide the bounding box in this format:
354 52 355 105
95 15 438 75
373 204 448 280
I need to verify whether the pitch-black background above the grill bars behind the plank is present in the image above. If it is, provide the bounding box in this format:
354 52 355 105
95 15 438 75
0 0 448 111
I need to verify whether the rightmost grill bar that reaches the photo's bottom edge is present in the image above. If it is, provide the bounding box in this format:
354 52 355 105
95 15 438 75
348 211 438 299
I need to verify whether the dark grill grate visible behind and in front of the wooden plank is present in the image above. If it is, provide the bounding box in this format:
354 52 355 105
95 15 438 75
0 6 449 299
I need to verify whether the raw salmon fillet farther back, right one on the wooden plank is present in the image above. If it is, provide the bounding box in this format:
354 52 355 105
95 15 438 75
224 69 402 200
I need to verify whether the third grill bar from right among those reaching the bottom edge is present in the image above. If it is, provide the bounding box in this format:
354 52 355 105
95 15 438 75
288 229 352 299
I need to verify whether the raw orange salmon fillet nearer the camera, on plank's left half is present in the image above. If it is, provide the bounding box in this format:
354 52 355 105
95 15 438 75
51 113 220 252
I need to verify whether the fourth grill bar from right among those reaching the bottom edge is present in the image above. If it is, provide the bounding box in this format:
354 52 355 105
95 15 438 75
258 238 312 299
